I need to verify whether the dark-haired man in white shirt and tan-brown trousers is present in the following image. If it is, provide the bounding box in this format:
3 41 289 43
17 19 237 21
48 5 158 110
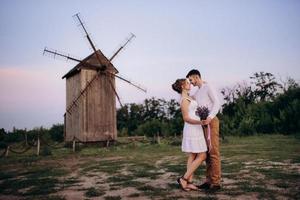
186 69 221 191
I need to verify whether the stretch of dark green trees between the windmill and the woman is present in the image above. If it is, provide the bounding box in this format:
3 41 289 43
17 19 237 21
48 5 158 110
117 97 183 136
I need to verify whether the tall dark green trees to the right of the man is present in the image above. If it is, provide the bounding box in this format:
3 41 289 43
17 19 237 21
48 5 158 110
219 72 300 135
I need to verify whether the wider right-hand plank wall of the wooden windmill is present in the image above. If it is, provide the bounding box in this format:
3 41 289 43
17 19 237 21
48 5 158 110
81 69 117 142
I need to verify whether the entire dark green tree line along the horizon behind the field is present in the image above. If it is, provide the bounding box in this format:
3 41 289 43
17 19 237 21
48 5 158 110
0 72 300 147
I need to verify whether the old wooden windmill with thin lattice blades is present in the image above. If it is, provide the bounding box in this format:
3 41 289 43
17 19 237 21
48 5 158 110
43 13 146 142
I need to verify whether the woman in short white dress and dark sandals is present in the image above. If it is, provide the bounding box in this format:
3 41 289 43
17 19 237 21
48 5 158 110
172 79 207 191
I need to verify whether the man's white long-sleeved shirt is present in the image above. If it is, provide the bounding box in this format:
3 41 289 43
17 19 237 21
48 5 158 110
193 83 221 119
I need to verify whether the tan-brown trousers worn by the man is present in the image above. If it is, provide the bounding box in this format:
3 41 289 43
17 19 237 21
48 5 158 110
205 117 221 185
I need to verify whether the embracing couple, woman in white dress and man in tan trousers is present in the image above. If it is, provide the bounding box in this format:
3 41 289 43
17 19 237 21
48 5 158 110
172 69 221 192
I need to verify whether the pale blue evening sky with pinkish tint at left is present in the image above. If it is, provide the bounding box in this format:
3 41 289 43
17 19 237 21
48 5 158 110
0 0 300 130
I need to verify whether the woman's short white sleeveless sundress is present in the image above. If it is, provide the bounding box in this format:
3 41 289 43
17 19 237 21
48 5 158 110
181 99 207 153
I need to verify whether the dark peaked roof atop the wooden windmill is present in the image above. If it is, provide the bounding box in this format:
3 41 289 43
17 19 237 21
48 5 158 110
62 50 119 79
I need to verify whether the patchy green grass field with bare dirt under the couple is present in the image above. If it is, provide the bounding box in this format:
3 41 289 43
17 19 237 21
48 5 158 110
0 135 300 200
